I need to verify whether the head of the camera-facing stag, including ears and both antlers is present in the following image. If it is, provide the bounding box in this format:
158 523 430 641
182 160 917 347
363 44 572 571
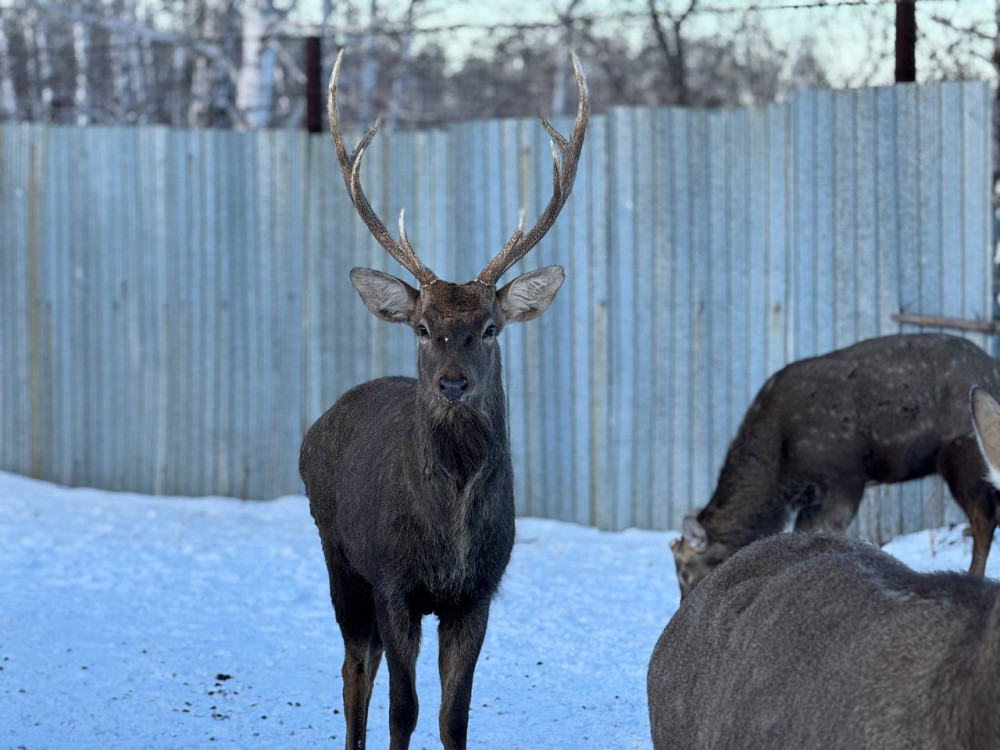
327 52 590 418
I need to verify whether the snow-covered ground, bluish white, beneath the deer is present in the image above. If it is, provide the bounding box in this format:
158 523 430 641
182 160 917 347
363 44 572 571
0 473 1000 750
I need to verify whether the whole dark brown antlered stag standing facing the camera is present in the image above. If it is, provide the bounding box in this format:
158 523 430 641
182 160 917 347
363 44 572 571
299 51 590 750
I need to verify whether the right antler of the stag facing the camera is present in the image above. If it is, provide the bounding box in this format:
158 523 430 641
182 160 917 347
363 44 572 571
476 54 590 284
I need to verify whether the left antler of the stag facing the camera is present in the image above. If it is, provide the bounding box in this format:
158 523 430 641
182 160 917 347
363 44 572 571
326 50 437 286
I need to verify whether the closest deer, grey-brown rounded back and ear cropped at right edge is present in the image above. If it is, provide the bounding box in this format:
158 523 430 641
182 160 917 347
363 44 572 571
646 388 1000 750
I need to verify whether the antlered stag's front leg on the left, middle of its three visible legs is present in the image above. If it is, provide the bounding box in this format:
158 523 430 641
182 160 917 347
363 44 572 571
376 596 420 750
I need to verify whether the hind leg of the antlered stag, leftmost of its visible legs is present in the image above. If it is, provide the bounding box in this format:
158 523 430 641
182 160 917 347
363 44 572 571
323 540 382 750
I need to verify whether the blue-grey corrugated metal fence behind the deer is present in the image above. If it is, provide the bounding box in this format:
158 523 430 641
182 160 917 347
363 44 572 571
0 83 992 536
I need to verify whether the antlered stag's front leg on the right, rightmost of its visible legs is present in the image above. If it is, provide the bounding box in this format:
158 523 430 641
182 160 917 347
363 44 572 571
438 601 490 750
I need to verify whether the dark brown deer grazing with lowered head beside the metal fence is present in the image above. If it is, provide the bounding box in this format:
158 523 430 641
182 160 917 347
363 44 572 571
670 333 1000 599
